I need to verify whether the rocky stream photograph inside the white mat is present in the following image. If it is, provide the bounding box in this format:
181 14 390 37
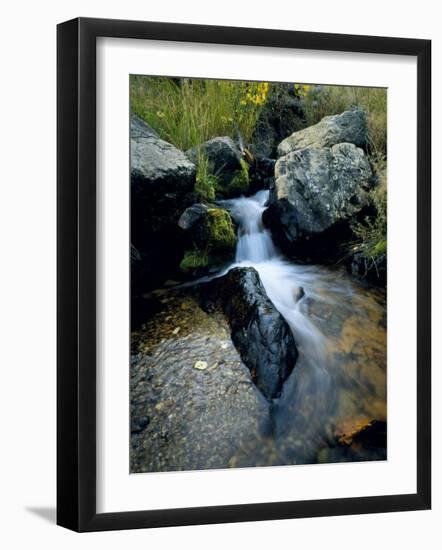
128 74 388 473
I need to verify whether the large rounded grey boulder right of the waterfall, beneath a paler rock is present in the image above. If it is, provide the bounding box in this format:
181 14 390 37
263 143 373 257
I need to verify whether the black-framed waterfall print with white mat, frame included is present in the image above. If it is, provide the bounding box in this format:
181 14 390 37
57 18 431 531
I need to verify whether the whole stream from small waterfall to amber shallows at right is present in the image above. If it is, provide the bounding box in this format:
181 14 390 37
222 191 386 463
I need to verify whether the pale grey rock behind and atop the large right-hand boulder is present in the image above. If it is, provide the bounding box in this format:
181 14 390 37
278 109 367 157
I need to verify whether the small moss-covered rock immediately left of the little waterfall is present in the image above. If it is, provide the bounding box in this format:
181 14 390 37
180 208 236 273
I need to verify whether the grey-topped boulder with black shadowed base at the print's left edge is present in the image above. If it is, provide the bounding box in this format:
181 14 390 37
131 116 196 287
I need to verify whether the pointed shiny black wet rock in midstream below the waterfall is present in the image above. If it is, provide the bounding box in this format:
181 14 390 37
202 267 298 399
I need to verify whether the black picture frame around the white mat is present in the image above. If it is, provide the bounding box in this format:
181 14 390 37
57 18 431 531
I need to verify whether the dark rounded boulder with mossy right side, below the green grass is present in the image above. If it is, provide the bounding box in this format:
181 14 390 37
186 136 249 198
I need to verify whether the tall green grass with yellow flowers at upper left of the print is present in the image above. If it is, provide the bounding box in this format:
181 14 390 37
130 75 268 151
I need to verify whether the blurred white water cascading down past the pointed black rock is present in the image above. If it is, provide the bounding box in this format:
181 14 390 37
223 191 354 462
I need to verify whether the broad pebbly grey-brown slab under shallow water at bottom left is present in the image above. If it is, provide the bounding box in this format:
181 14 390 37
130 291 270 473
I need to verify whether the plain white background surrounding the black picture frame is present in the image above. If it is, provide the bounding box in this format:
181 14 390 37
0 0 442 550
